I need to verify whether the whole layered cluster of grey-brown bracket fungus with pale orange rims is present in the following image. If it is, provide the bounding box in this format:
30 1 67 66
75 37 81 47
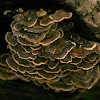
0 9 100 91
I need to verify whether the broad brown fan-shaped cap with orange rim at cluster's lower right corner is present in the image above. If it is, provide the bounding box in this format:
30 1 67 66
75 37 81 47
71 66 99 89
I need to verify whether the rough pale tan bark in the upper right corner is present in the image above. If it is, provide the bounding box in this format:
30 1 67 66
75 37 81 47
65 0 100 39
